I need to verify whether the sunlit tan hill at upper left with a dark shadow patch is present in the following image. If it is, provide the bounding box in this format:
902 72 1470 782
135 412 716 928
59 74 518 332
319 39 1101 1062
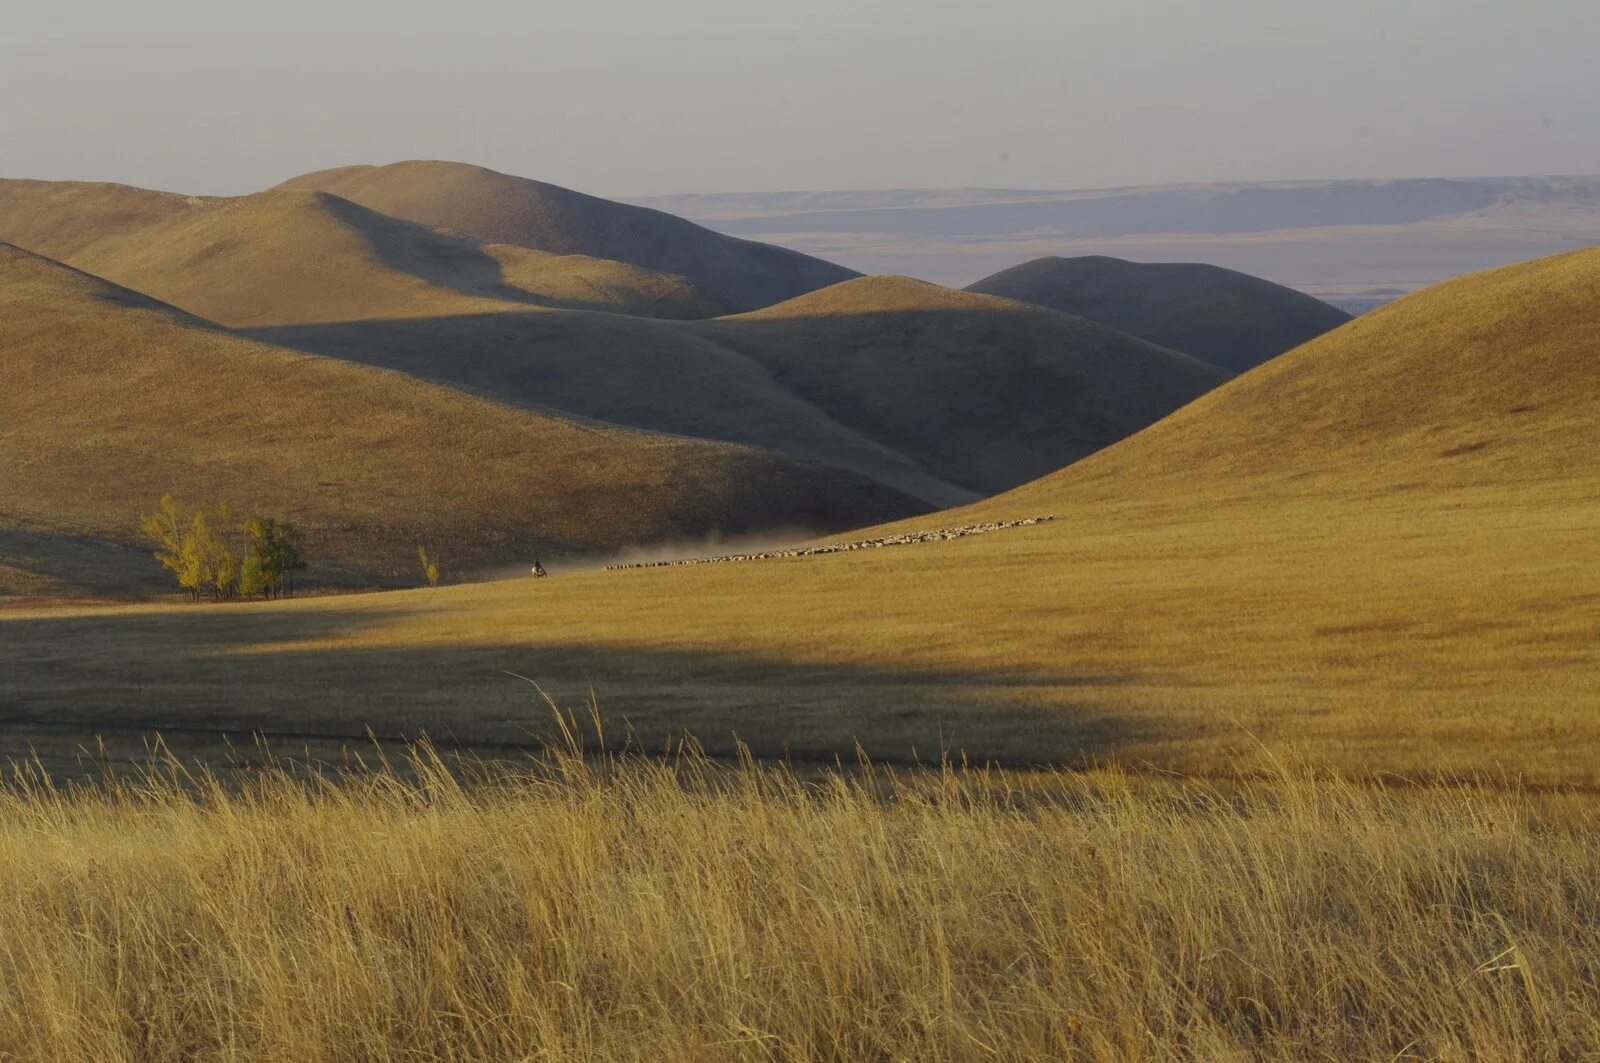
0 183 720 327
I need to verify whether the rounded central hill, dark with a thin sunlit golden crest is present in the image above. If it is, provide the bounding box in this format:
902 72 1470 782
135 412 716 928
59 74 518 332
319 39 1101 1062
693 277 1229 493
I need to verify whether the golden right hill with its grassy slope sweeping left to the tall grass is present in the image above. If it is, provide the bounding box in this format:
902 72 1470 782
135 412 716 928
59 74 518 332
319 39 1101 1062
0 250 1600 788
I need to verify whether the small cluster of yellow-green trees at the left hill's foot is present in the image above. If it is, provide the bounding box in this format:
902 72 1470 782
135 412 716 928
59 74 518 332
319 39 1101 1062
141 495 306 602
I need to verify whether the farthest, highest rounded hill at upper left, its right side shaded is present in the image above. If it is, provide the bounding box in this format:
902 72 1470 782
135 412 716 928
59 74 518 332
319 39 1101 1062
278 162 854 309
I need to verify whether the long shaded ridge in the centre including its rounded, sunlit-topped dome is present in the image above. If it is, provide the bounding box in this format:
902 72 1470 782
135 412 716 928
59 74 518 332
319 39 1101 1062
253 277 1229 506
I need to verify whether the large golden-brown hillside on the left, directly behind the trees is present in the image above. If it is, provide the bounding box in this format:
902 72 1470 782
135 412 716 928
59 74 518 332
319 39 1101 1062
0 245 918 589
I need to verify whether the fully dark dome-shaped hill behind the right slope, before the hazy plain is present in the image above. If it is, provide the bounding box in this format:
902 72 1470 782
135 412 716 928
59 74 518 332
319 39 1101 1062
966 255 1350 373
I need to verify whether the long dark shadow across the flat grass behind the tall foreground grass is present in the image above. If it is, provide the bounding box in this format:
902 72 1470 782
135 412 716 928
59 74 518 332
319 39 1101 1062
0 607 1150 767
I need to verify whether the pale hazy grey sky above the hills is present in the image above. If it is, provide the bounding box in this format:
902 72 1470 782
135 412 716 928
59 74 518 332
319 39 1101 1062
0 0 1600 195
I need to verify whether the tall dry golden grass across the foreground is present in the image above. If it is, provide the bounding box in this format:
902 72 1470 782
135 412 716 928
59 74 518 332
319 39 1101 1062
0 742 1600 1060
